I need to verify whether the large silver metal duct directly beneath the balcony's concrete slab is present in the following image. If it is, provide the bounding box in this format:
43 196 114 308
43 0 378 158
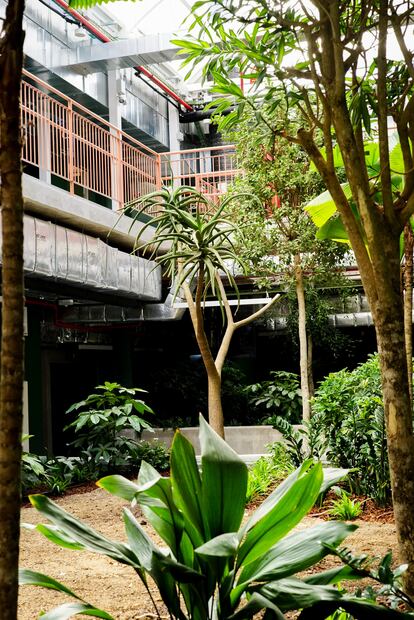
0 215 161 301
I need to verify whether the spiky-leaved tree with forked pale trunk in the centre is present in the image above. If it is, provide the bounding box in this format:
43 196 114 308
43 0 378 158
128 186 279 437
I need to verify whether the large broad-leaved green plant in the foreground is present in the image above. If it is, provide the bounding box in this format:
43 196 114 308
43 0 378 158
21 419 411 620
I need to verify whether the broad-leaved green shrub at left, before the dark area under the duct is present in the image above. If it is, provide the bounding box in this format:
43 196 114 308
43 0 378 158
66 381 153 475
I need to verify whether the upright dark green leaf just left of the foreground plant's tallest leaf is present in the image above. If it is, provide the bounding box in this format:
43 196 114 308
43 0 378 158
171 431 205 547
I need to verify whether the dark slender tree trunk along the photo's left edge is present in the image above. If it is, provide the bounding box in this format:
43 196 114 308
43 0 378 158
0 0 24 620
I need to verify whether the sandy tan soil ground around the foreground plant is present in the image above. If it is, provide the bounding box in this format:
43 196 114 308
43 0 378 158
18 489 398 620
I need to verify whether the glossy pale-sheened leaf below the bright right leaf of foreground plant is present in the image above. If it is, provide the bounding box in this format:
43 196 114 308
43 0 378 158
238 522 357 584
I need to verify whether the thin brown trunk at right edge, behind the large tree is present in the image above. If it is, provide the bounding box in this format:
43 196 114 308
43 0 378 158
404 222 414 403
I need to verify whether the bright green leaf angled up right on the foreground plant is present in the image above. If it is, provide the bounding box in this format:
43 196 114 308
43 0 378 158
237 463 323 565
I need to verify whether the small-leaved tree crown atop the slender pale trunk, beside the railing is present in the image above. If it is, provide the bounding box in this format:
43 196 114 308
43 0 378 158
222 105 346 288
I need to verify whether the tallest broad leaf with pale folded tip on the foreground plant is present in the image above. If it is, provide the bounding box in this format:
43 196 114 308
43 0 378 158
200 416 248 539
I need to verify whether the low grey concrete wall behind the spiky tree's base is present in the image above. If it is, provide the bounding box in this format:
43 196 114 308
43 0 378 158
141 426 298 455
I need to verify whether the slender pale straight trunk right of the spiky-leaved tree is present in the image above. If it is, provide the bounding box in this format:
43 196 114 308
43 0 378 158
294 254 310 422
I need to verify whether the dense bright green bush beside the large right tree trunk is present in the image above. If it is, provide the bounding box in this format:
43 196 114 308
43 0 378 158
312 355 391 504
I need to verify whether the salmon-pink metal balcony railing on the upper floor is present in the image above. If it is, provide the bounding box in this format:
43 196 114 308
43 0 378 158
21 71 238 210
